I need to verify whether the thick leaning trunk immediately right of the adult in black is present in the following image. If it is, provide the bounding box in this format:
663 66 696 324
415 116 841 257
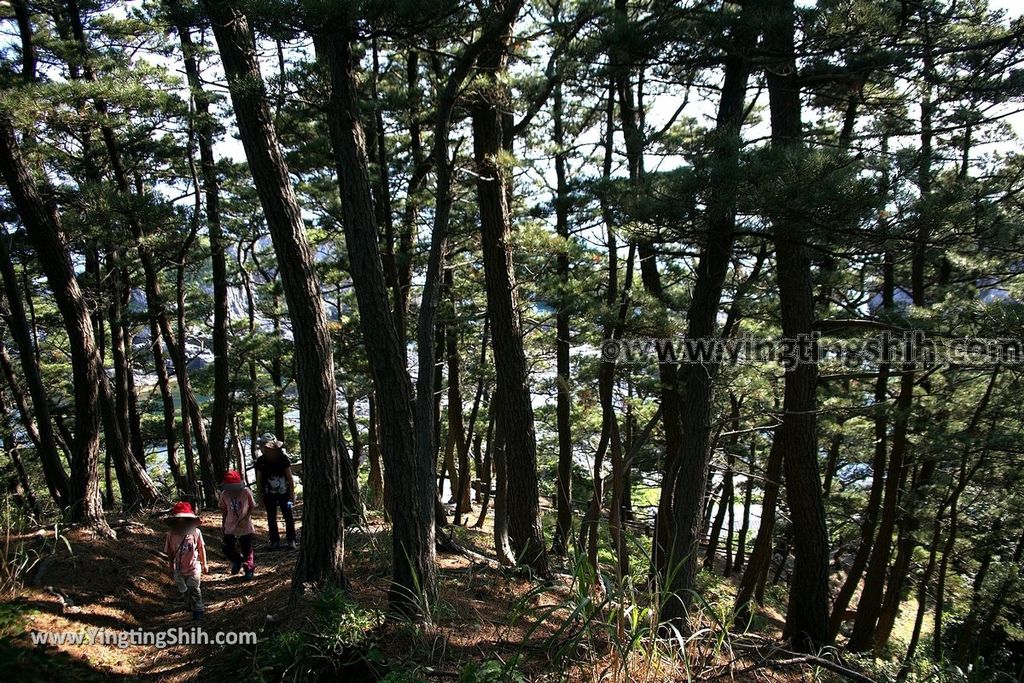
203 0 347 596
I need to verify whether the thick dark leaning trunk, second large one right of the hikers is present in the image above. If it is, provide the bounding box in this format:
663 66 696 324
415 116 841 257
317 27 436 616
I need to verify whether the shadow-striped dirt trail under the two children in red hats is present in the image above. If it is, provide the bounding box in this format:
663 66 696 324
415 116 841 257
0 510 296 681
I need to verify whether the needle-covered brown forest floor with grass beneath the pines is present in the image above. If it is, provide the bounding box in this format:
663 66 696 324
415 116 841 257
0 511 864 683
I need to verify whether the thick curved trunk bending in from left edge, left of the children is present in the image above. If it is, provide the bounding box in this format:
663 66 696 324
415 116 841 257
0 117 111 533
